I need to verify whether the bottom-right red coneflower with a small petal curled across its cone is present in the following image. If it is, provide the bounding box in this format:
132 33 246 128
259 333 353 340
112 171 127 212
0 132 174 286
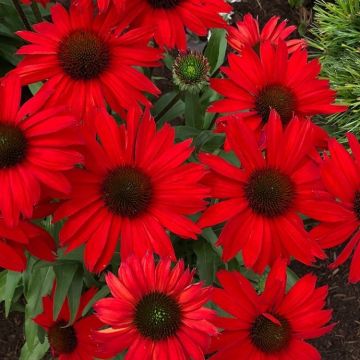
211 260 335 360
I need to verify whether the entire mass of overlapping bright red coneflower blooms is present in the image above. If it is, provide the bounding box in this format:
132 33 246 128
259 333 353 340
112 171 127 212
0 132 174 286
0 0 360 360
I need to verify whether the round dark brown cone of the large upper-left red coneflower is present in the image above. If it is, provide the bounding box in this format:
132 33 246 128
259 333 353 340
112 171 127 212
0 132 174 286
58 30 110 80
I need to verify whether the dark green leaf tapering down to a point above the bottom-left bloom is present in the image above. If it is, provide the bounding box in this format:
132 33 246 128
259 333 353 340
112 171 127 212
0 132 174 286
53 264 78 319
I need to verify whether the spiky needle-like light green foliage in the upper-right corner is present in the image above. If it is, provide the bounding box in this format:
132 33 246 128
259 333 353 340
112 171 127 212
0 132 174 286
309 0 360 141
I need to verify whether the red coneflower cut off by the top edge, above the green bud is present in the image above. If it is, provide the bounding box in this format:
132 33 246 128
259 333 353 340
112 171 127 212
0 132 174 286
115 0 232 50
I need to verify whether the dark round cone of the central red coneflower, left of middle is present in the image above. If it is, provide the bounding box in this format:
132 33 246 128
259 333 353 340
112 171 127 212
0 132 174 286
102 166 153 217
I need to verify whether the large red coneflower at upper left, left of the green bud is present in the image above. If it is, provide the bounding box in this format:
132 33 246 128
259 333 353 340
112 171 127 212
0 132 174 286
15 0 161 119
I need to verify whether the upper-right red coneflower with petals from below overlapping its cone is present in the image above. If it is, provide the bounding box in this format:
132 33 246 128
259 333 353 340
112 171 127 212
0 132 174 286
209 40 347 135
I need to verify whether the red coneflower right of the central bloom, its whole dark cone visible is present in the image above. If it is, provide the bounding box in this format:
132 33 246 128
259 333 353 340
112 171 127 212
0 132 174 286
198 110 327 273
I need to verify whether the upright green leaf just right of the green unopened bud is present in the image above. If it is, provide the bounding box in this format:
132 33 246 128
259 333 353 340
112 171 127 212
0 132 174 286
204 29 227 75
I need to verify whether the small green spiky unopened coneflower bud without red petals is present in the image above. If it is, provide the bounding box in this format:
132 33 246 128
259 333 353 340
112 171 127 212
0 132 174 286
172 53 210 93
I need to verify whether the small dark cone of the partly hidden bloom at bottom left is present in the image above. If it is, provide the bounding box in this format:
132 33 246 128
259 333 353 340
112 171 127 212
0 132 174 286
48 321 78 354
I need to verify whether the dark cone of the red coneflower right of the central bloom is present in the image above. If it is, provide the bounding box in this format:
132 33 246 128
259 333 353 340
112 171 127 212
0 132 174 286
244 168 295 217
